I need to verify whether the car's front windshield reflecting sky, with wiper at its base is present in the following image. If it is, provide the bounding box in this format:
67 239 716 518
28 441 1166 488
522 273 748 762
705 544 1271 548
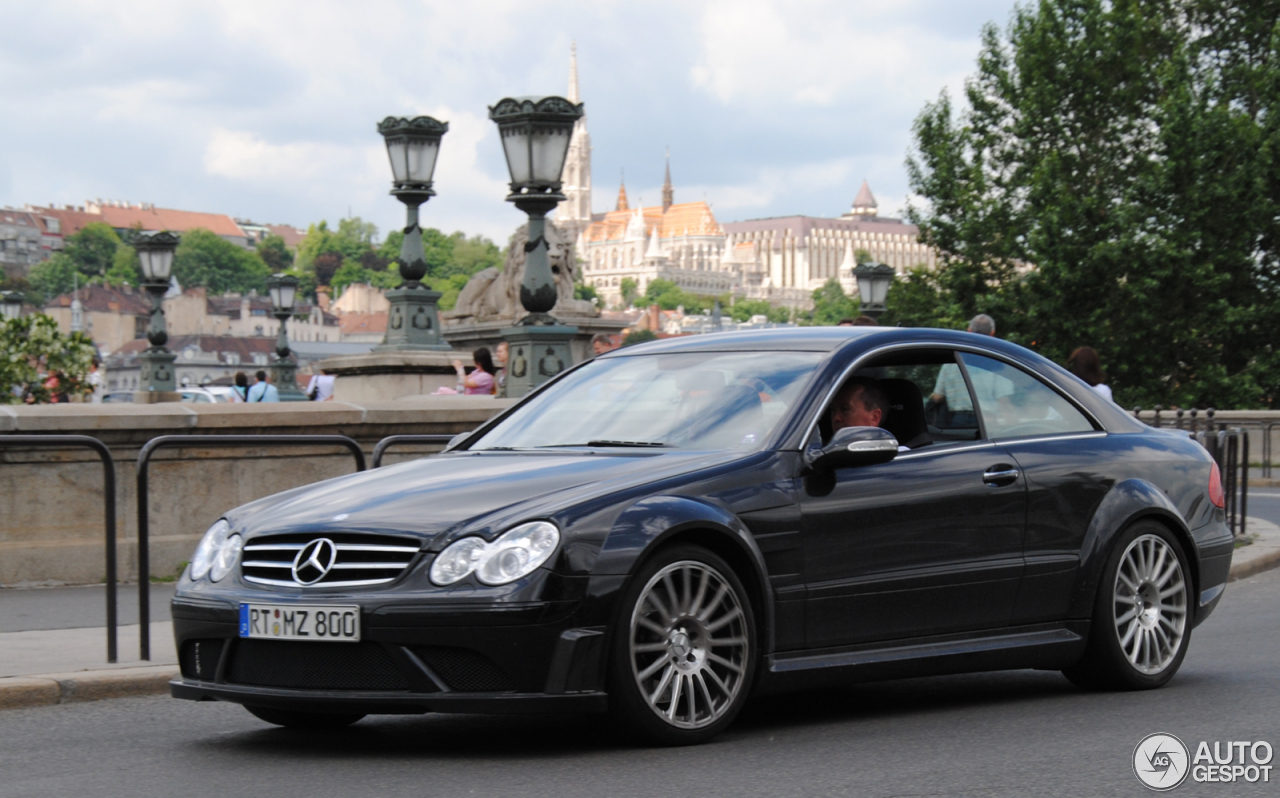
468 352 822 450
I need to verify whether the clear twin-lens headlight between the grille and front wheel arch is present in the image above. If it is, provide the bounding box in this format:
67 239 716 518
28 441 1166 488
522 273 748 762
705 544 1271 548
431 521 559 587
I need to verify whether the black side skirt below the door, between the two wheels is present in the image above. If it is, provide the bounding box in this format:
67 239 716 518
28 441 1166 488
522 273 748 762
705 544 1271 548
758 621 1089 692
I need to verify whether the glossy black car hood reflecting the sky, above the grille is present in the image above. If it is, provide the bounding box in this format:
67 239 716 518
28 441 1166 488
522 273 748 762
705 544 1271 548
227 450 744 538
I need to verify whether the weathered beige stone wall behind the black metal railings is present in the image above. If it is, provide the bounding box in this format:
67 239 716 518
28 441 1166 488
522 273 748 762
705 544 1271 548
0 397 512 587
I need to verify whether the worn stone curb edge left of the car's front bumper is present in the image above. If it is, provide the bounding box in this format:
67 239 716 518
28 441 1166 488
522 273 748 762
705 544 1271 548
0 665 178 710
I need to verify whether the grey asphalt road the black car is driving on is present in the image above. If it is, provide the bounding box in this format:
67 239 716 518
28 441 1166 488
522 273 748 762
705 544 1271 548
0 571 1280 798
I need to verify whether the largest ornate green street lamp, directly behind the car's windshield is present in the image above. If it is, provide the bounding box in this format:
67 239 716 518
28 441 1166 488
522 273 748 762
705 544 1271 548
489 96 582 396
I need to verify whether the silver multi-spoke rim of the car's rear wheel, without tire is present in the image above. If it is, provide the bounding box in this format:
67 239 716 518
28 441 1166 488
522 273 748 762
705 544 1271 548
1115 534 1187 674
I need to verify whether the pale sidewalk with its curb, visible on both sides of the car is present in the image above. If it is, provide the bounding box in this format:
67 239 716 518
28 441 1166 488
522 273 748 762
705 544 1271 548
0 517 1280 710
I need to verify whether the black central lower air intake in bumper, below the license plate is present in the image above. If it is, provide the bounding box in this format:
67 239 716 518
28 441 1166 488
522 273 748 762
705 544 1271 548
227 640 410 690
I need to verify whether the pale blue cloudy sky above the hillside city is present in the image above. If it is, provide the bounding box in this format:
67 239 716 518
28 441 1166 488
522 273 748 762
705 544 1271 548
0 0 1014 240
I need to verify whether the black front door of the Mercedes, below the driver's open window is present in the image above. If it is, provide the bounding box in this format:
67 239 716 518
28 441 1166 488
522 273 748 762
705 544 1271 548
797 350 1027 648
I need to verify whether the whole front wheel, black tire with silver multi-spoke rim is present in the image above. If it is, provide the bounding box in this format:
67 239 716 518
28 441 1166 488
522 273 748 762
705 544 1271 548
609 546 758 745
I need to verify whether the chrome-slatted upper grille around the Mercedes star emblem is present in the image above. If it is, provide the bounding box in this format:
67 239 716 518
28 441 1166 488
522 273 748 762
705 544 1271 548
241 532 422 588
